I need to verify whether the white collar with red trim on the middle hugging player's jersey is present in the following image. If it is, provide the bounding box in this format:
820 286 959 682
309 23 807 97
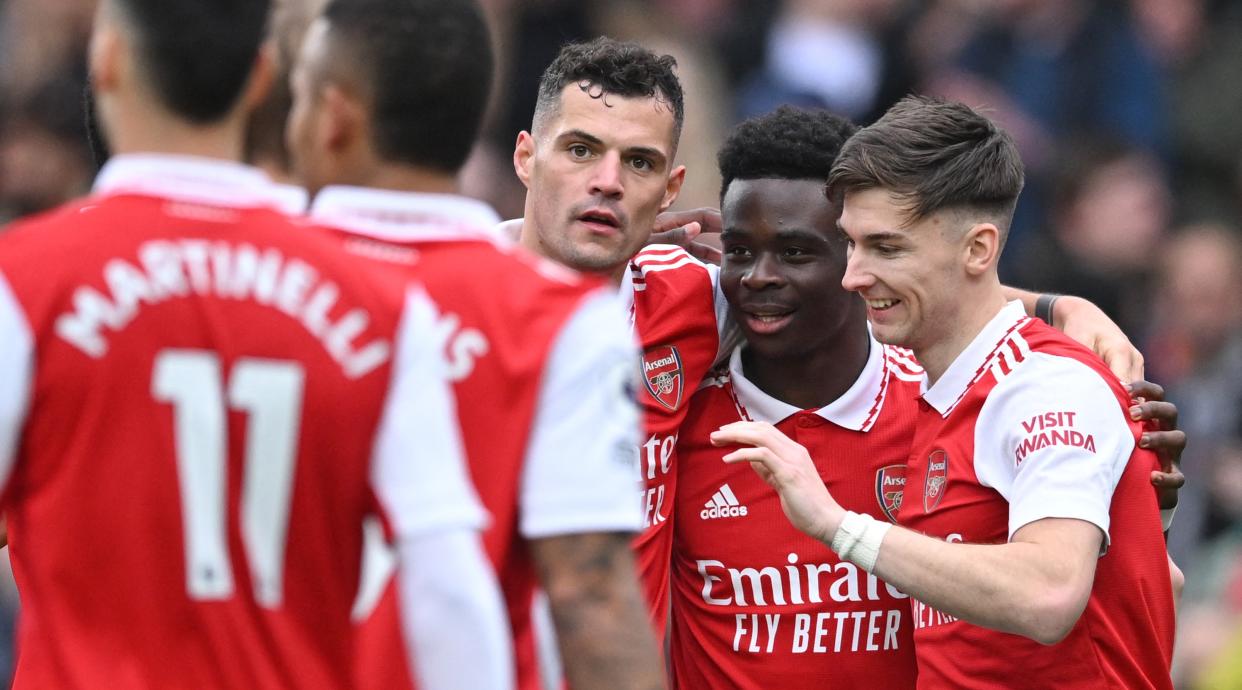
729 328 888 432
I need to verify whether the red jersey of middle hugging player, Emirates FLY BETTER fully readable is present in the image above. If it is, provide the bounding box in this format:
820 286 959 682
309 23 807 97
669 340 924 690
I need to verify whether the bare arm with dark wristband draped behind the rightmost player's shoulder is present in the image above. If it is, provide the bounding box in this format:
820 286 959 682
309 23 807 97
1004 287 1143 383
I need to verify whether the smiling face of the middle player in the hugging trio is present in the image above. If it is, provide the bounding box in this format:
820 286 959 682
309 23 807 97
720 179 858 357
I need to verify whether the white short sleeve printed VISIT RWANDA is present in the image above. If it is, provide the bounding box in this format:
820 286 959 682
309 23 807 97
975 352 1134 546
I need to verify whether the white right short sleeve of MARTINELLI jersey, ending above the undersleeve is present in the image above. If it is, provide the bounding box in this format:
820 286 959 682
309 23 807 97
371 288 486 540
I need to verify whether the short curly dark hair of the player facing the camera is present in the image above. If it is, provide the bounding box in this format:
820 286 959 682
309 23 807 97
534 36 686 146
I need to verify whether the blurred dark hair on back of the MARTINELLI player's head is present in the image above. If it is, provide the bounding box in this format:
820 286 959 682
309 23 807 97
111 0 271 124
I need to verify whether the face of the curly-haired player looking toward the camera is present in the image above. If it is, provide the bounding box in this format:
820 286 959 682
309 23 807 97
514 84 686 273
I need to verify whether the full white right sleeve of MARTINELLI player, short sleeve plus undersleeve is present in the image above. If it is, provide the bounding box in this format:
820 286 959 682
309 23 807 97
371 282 513 690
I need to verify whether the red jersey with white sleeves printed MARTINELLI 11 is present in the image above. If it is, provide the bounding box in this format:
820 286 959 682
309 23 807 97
0 155 489 689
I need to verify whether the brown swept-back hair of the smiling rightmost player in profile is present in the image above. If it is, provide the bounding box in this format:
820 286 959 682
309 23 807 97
828 96 1023 236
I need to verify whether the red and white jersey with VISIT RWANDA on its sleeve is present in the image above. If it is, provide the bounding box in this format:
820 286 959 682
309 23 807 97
898 302 1174 690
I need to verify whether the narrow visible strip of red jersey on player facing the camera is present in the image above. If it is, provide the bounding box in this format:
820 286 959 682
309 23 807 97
621 244 728 639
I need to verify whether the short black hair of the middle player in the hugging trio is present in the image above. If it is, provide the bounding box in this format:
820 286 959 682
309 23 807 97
715 105 858 199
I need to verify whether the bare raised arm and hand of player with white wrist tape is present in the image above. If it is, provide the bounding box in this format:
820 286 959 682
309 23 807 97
712 422 1103 644
